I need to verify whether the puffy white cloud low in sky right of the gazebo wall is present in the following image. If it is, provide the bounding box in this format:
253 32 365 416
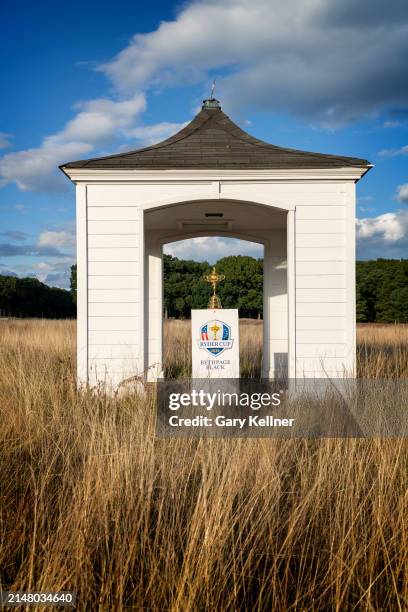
356 210 408 241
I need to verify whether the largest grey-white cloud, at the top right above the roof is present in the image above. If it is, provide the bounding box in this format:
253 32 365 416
100 0 408 127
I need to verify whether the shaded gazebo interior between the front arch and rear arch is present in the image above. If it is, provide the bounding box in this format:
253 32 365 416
144 200 288 380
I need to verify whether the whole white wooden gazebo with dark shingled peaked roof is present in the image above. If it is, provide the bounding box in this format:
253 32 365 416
61 99 371 385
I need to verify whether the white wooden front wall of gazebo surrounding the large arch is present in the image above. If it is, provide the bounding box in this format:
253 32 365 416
78 177 355 382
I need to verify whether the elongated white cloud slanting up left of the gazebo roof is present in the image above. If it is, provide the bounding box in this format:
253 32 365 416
0 94 146 191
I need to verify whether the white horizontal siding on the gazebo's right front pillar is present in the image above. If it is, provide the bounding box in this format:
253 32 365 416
296 184 354 377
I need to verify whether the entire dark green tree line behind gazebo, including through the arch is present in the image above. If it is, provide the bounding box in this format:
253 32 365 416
0 255 408 323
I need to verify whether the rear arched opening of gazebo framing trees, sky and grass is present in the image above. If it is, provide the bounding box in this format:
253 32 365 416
163 236 264 378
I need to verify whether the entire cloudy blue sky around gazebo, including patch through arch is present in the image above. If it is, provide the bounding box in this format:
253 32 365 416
0 0 408 287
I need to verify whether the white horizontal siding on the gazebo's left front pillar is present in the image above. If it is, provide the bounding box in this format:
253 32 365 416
88 198 144 384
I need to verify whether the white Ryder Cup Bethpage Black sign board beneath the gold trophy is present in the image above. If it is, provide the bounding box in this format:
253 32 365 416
191 308 239 378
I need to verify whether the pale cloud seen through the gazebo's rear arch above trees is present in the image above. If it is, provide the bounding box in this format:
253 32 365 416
164 236 263 264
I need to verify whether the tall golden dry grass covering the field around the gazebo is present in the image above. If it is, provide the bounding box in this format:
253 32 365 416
0 320 408 611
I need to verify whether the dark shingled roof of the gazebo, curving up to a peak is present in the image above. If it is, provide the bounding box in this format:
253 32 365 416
61 99 370 170
